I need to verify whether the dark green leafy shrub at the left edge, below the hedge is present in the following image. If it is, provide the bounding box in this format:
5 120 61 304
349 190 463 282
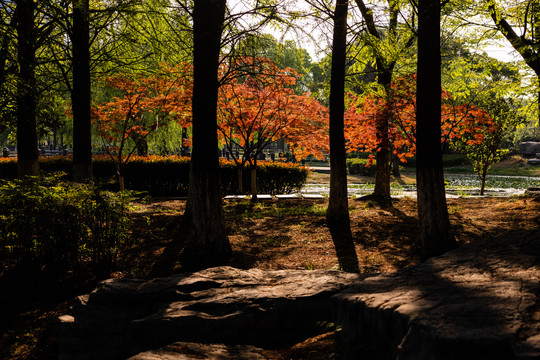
0 175 129 271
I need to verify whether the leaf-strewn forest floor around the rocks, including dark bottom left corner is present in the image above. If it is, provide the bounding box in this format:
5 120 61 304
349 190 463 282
0 193 540 359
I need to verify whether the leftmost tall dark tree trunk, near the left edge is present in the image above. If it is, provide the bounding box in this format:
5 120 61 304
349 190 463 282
16 0 39 177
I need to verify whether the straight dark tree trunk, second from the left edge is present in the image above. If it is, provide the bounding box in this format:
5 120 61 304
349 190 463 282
71 0 92 182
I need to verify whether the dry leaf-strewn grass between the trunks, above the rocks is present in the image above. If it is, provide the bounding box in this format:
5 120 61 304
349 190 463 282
116 197 540 278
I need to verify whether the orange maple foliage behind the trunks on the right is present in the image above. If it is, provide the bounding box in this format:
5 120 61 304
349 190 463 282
345 74 497 166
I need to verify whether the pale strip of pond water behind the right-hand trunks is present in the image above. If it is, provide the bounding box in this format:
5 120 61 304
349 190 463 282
301 174 540 197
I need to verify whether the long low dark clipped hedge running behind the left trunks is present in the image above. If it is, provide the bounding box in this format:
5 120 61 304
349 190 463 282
0 155 308 196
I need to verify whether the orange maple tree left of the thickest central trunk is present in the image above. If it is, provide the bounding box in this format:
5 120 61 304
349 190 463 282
92 64 192 190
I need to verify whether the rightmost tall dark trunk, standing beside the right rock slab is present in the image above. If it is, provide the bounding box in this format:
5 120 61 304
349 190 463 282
416 0 456 258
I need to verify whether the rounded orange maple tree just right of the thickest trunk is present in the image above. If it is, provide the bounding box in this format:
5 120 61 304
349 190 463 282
218 57 328 197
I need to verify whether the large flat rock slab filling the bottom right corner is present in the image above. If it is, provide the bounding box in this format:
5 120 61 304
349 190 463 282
332 231 540 360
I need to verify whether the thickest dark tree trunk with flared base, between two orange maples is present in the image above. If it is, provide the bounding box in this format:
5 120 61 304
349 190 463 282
184 0 232 268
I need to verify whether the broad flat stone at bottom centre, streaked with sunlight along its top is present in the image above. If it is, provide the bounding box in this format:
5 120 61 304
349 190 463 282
60 267 360 360
